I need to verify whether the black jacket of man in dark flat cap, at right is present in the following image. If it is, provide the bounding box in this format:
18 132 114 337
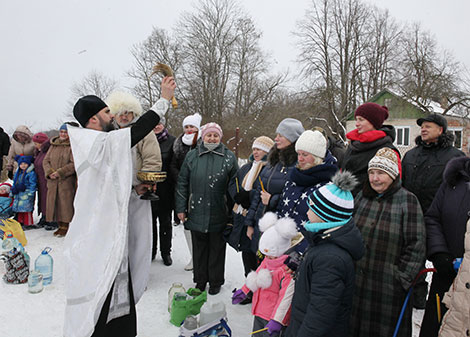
401 133 465 213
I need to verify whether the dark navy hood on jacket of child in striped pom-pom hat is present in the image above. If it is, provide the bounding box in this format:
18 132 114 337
303 219 365 261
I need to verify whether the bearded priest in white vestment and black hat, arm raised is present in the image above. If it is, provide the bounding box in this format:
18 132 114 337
64 77 176 337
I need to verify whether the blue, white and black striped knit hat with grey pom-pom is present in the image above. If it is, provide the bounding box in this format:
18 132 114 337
308 171 357 226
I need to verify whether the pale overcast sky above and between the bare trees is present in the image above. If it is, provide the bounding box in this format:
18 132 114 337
0 0 470 134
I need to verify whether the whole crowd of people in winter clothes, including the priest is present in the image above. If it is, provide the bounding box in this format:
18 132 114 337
0 77 470 337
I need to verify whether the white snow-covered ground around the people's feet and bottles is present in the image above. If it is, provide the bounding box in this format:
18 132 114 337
0 222 423 337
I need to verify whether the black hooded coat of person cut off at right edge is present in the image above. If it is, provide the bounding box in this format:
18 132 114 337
424 157 470 257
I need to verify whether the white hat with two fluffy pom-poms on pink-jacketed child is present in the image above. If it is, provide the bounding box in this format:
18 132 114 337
258 212 297 257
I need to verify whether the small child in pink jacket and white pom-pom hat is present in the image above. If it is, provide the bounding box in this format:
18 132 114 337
232 213 297 337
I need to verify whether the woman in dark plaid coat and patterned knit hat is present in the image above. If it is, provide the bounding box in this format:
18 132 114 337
349 148 425 337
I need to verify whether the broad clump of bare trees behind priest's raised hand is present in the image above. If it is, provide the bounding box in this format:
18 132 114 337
128 0 286 129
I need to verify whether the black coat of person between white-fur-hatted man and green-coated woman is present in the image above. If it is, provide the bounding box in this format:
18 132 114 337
154 134 176 212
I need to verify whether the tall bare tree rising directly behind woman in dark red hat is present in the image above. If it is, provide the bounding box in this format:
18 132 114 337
296 0 370 133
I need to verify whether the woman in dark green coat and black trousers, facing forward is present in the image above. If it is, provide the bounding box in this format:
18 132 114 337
175 123 238 295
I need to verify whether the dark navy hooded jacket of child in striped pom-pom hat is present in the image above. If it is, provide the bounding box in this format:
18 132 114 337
286 219 364 337
